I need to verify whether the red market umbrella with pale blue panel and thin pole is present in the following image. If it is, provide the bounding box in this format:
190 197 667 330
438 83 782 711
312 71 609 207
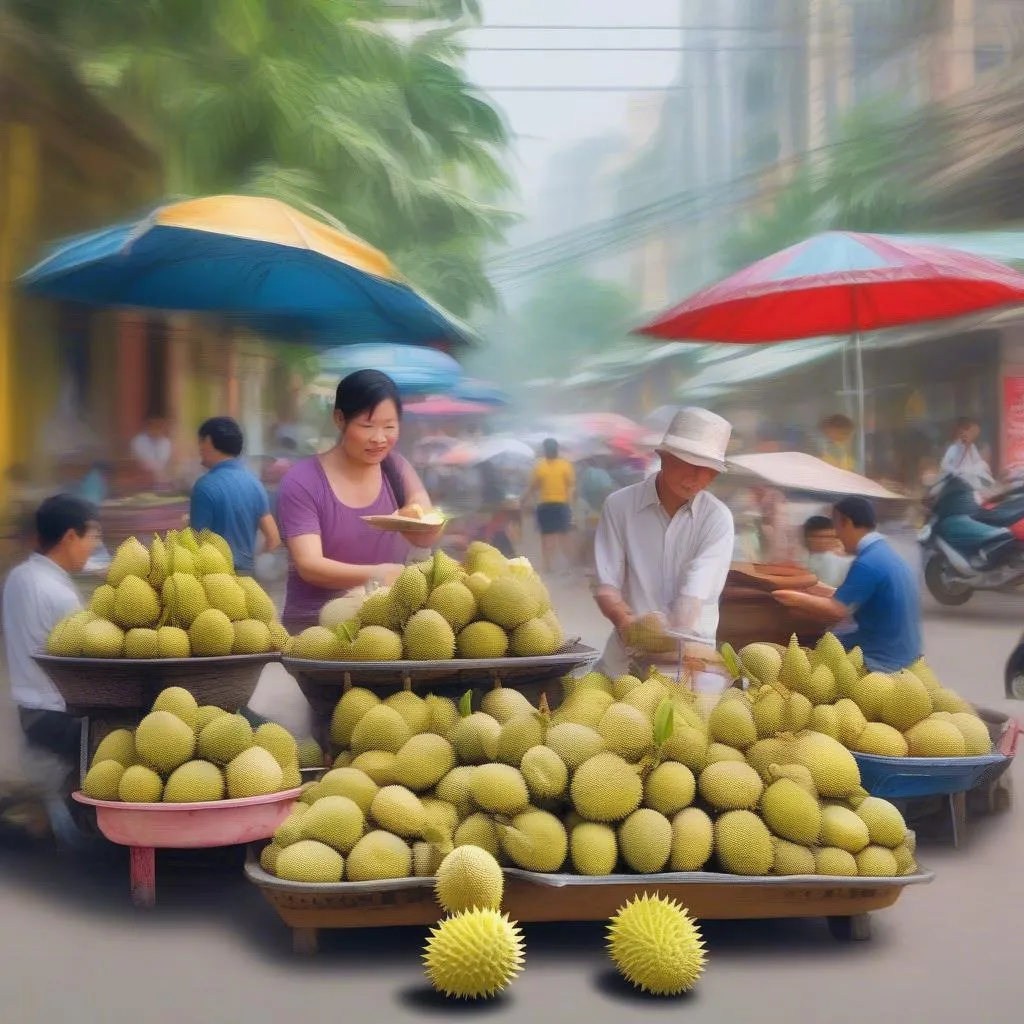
635 231 1024 467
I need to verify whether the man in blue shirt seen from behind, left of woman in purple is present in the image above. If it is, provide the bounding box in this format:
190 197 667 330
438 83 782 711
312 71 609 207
189 416 281 575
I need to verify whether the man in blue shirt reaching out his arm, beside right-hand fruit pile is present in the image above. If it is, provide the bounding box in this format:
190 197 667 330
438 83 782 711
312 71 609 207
773 498 923 672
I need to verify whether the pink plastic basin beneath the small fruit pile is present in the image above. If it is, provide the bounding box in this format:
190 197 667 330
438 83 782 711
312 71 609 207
73 790 302 850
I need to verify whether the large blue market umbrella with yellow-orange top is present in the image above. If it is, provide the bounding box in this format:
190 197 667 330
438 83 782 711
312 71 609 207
20 196 473 346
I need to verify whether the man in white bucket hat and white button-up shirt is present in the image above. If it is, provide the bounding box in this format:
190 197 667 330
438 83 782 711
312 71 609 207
594 408 735 677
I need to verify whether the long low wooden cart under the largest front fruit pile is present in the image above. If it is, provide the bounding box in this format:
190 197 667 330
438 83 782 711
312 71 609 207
246 860 934 953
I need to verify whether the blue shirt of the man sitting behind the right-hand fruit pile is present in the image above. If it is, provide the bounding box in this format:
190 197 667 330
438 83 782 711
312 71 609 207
835 534 923 672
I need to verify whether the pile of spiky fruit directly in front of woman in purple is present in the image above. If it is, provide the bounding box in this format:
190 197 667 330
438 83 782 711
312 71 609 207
289 542 565 662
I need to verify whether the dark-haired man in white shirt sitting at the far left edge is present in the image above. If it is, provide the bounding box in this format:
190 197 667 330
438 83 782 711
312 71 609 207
3 495 99 831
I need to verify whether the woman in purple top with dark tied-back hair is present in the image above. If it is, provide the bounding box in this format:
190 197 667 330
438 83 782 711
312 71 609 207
276 370 441 634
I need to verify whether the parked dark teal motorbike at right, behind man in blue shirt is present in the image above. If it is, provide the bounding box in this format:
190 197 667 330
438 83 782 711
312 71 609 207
918 475 1024 606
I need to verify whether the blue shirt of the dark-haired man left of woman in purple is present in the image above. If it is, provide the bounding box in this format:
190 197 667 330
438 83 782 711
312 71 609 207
189 459 270 573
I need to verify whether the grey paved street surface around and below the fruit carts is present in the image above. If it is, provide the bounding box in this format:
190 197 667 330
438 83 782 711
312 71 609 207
0 565 1024 1024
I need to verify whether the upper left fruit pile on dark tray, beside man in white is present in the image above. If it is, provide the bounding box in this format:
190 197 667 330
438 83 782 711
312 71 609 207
46 528 291 659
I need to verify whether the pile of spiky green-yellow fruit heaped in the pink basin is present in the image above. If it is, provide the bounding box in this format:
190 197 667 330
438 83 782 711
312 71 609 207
82 686 322 804
